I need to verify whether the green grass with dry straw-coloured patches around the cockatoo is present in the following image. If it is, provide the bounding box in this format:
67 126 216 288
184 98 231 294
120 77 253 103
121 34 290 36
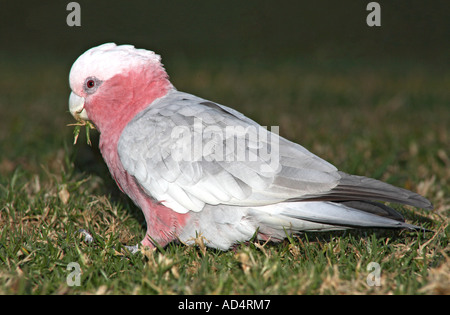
0 57 450 294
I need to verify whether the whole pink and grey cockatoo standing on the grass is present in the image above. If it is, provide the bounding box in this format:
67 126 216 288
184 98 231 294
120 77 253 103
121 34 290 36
69 43 432 250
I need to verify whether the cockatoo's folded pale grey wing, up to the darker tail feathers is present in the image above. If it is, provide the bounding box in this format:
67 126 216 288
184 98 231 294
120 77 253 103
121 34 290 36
118 91 341 213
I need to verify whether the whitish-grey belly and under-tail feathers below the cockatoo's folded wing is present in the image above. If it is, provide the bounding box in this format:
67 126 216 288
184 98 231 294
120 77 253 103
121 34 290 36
179 201 426 250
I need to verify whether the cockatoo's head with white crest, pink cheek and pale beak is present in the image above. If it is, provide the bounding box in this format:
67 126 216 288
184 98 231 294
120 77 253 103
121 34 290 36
69 43 173 132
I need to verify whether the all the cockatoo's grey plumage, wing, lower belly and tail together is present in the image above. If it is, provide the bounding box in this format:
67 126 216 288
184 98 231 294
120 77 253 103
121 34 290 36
118 90 432 249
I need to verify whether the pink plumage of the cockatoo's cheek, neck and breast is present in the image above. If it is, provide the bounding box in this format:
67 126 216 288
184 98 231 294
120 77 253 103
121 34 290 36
86 71 189 246
